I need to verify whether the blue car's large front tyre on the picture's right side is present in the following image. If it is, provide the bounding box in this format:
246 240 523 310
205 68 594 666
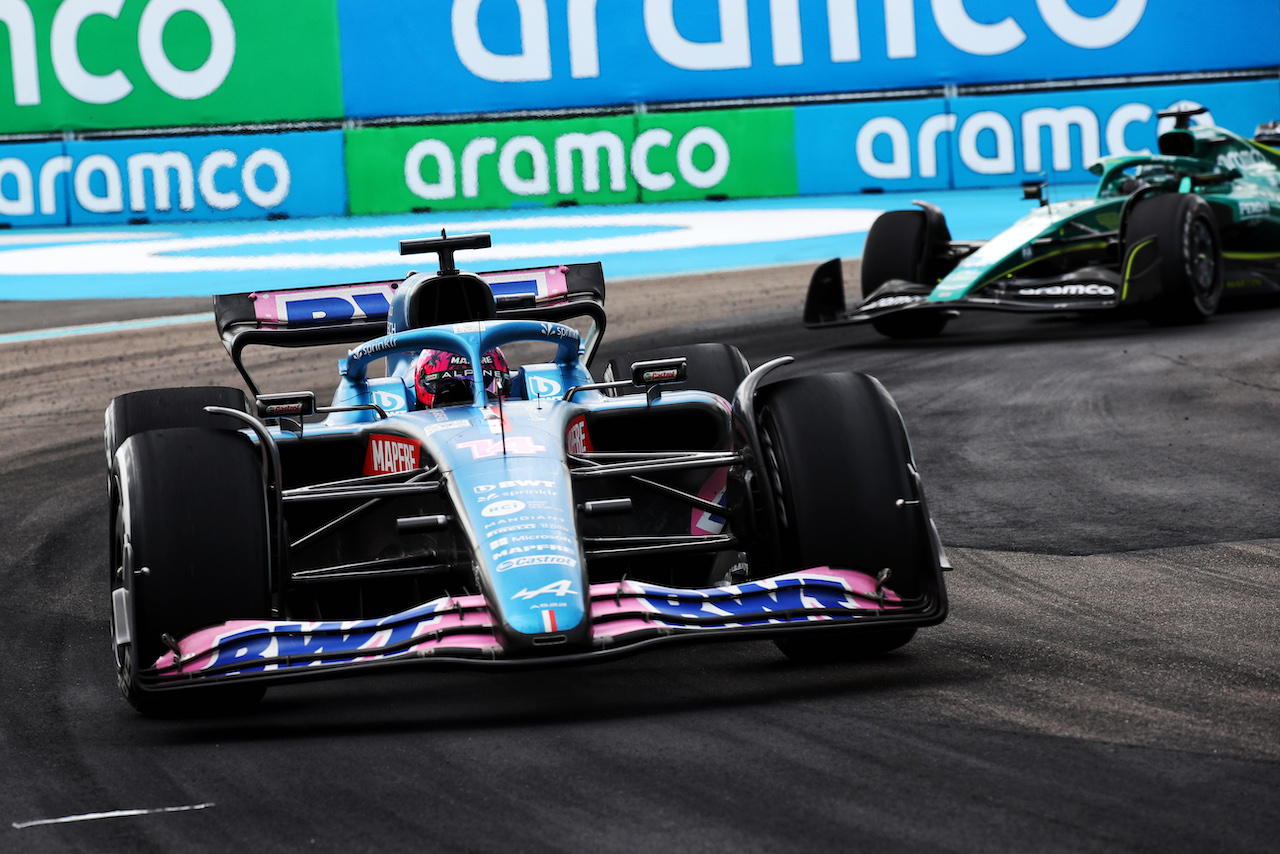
756 374 932 662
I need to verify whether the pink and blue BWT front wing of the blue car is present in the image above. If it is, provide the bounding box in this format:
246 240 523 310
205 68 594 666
138 567 946 690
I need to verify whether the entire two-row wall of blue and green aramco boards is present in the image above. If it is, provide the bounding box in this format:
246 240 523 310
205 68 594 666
0 0 1280 227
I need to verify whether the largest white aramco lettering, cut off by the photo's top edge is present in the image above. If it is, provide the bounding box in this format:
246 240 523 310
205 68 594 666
452 0 1147 83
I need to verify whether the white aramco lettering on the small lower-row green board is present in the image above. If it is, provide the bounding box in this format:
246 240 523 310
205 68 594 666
404 127 730 200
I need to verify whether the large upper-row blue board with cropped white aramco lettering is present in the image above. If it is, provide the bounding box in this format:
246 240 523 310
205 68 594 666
338 0 1280 118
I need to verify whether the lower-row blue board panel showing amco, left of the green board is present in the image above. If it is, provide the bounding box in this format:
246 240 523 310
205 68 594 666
61 131 347 225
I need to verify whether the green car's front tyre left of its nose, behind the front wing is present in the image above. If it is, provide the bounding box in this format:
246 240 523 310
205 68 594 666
861 210 951 338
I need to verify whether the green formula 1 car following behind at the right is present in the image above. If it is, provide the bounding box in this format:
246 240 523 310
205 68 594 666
804 109 1280 338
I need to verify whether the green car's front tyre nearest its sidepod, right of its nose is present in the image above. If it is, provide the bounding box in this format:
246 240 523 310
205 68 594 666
1125 193 1222 326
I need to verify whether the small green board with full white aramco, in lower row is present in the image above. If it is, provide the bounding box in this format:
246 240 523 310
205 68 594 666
347 108 796 214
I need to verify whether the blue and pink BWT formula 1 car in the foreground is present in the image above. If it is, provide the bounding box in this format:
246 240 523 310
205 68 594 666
105 234 947 714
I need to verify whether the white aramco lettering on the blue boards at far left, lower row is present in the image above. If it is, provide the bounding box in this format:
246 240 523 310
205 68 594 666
0 149 292 216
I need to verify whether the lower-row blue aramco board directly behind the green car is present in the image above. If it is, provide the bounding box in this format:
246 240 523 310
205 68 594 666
795 81 1280 195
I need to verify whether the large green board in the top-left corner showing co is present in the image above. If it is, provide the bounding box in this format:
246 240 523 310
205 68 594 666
0 0 343 133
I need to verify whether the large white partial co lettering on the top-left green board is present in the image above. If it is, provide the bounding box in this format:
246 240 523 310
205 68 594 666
0 0 236 106
